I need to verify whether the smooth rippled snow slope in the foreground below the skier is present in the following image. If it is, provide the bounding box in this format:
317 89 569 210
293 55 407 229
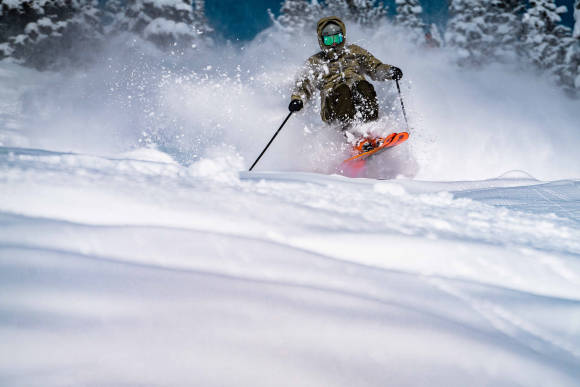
0 148 580 386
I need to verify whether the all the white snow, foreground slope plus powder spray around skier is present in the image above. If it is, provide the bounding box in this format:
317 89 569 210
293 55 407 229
0 19 580 387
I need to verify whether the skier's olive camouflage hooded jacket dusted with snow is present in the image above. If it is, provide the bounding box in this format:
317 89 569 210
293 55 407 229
292 16 392 120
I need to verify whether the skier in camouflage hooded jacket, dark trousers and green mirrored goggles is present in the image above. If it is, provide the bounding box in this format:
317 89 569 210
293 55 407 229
288 16 403 130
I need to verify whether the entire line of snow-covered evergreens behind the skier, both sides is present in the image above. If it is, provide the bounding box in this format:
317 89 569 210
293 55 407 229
0 0 580 91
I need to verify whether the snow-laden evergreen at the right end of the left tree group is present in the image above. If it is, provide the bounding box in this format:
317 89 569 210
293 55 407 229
112 0 211 48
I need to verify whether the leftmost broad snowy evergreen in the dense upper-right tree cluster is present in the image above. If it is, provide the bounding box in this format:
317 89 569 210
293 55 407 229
445 0 493 64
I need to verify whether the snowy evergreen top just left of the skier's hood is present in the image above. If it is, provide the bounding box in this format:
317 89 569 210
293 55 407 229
268 0 322 31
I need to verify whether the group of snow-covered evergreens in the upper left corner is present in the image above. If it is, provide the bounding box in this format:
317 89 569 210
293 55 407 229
0 0 211 70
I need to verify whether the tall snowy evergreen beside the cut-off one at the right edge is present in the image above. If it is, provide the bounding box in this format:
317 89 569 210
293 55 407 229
523 0 571 78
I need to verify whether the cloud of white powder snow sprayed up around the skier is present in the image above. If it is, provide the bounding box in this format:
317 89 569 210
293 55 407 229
5 17 580 180
